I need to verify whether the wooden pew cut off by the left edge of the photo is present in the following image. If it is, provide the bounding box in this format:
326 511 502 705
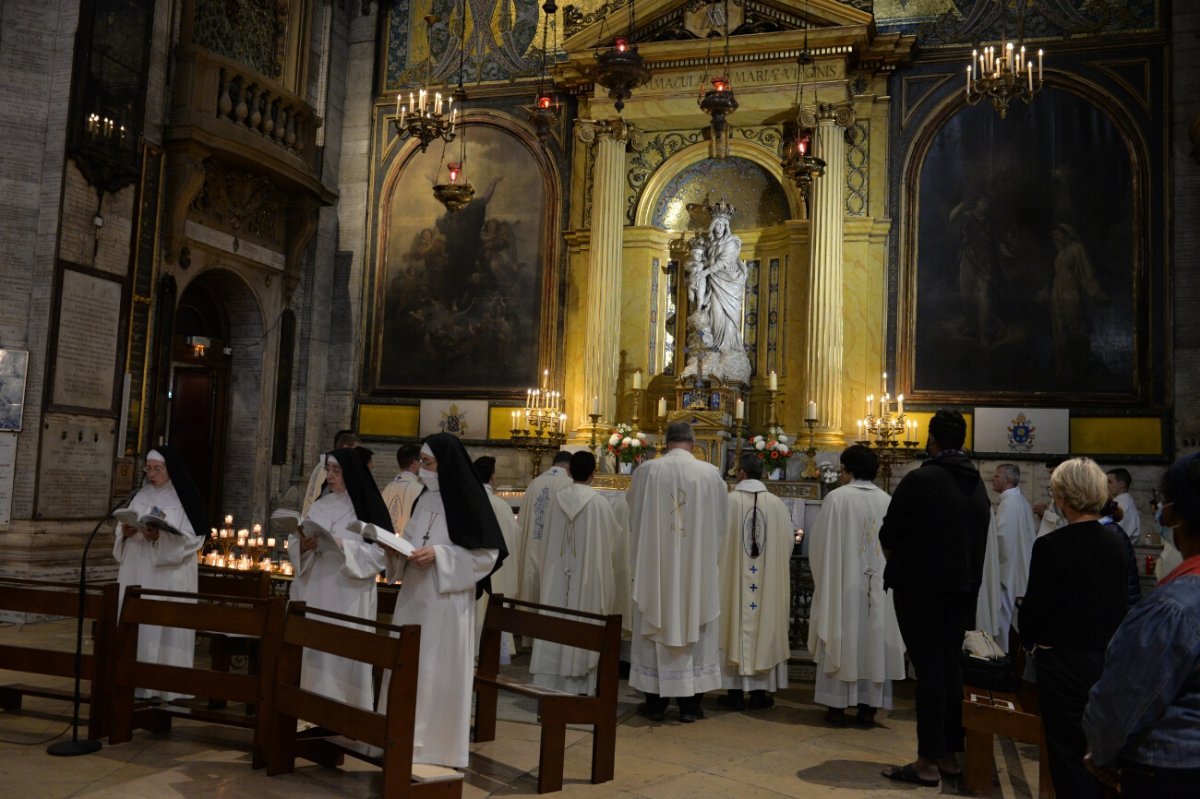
0 578 119 740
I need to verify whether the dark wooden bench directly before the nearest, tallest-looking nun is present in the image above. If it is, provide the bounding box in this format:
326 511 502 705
266 602 463 799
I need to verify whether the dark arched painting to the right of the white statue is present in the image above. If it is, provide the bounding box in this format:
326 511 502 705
899 85 1148 403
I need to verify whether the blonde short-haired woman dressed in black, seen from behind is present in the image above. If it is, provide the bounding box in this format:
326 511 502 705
1020 458 1128 799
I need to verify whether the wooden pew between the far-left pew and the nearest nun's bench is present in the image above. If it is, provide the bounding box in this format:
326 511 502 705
109 585 284 768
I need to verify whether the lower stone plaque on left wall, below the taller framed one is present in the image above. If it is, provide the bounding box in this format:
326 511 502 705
36 414 116 518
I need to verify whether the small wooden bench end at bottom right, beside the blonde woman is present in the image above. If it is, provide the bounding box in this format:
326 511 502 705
962 685 1055 799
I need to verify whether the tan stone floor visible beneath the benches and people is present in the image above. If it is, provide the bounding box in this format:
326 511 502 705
0 621 1037 799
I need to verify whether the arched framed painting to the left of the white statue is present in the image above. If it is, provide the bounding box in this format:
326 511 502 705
367 112 559 397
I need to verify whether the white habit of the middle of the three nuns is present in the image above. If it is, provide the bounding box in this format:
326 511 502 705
288 491 385 708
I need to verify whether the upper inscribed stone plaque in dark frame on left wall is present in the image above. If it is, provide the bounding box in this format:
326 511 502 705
54 269 121 410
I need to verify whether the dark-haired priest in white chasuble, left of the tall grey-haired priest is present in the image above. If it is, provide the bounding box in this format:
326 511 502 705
529 451 622 696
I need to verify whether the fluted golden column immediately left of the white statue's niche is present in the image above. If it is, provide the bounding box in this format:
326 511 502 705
576 119 632 425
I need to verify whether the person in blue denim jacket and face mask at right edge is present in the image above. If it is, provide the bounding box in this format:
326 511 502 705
1082 455 1200 799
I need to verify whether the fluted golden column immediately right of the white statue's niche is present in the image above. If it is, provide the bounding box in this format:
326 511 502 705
796 106 854 447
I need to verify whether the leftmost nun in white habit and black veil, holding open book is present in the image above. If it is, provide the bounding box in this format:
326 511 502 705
113 444 209 702
